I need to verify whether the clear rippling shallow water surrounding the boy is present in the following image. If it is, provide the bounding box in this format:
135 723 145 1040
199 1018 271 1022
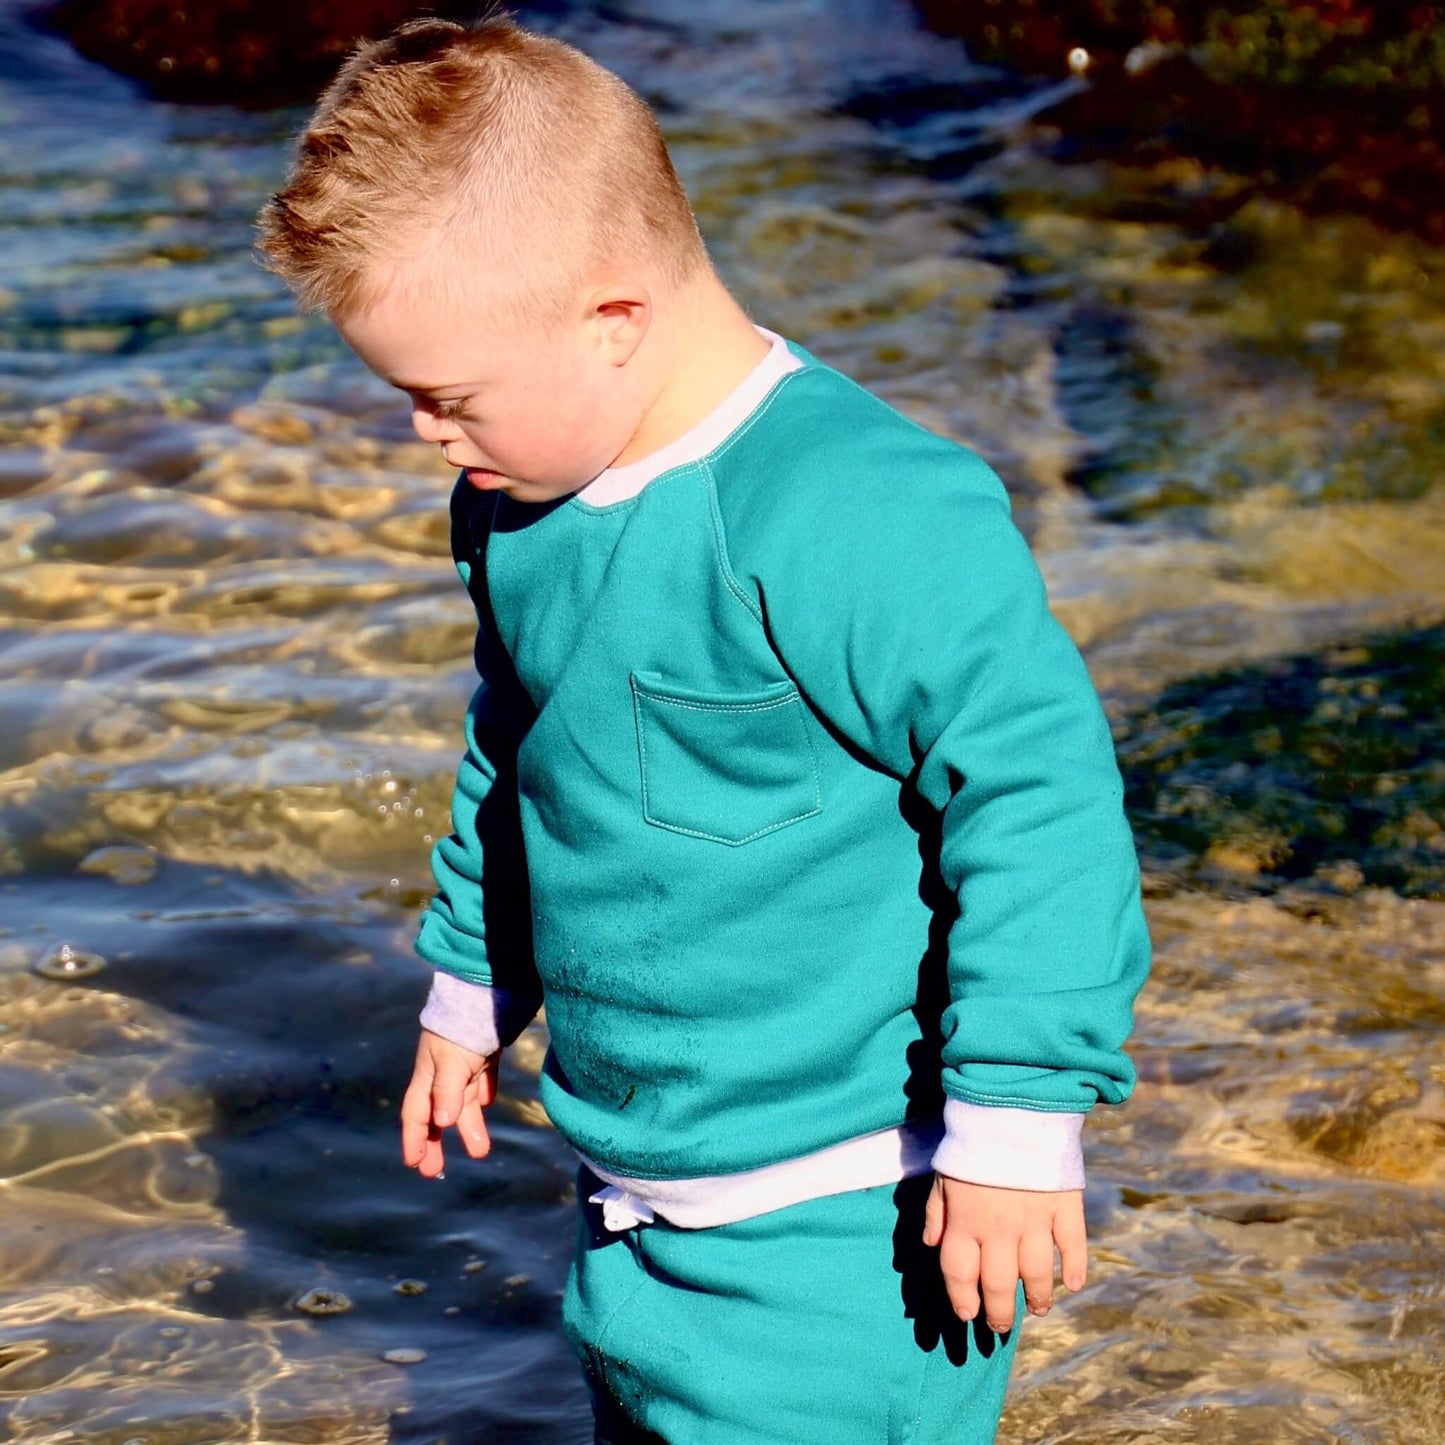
0 0 1445 1445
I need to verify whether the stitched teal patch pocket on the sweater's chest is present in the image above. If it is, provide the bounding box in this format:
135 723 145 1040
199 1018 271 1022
631 672 822 847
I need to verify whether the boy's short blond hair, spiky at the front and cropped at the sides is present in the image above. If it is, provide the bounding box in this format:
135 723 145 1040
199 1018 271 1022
257 14 707 314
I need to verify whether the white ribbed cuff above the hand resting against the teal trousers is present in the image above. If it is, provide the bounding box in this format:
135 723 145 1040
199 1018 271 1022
933 1098 1084 1191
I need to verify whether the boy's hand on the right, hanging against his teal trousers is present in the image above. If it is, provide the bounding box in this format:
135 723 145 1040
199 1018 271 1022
923 1173 1088 1335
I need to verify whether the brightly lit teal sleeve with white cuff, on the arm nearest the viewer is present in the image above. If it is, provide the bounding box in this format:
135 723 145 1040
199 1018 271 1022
734 434 1149 1188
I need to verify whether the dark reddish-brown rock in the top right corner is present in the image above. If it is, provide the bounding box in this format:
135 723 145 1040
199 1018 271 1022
915 0 1445 243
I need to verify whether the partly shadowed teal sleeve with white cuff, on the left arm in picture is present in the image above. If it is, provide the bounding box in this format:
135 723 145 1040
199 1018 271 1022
416 480 542 1052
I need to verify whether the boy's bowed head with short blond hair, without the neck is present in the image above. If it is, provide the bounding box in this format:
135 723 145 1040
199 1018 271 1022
259 17 709 500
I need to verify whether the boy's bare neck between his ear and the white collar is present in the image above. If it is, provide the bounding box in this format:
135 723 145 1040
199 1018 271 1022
613 272 769 467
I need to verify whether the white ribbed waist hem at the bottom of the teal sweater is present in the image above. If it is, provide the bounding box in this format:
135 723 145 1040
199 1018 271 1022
579 1118 944 1230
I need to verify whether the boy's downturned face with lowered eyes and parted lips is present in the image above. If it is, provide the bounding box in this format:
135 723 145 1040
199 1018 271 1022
332 268 639 501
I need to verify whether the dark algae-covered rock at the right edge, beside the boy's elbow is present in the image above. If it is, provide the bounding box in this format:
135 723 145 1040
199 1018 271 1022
1118 626 1445 899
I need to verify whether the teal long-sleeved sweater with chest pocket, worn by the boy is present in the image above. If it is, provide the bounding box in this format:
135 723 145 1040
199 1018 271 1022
416 348 1149 1179
